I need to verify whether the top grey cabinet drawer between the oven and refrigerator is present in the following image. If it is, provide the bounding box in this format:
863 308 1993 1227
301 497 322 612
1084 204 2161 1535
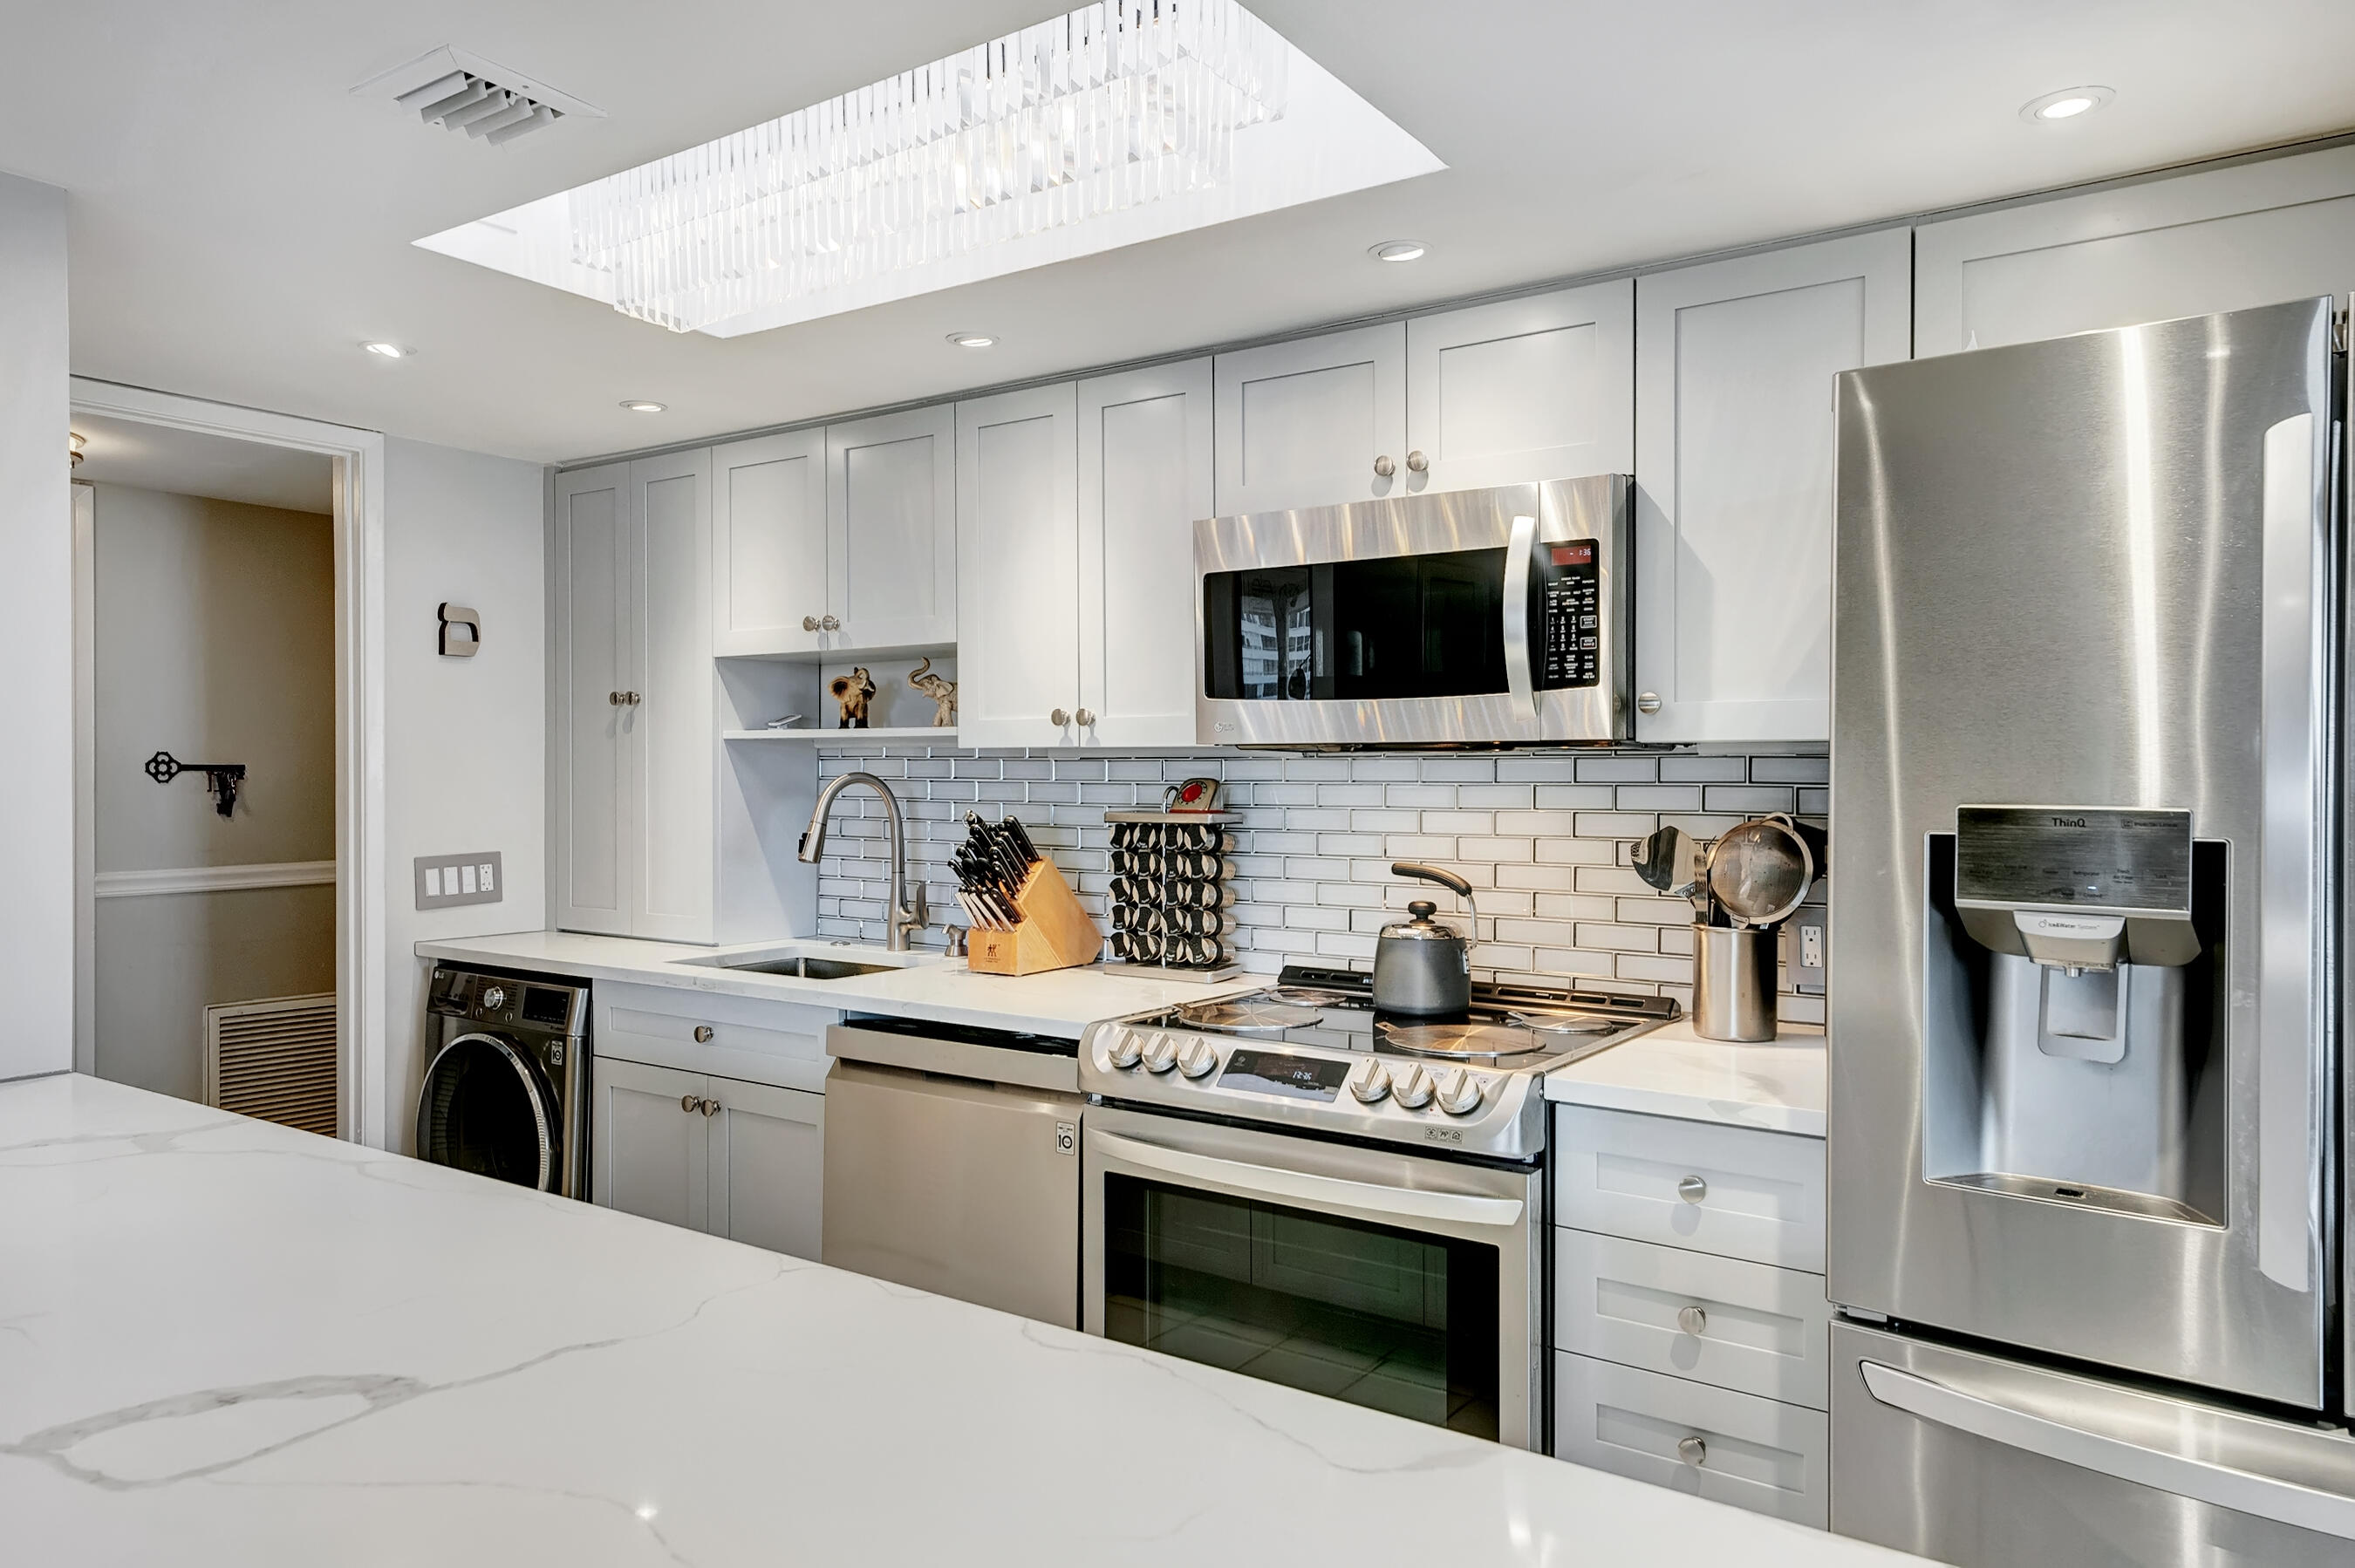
1554 1104 1823 1274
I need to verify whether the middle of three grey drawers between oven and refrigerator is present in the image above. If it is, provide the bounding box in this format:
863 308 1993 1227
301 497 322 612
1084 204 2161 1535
1554 1231 1830 1410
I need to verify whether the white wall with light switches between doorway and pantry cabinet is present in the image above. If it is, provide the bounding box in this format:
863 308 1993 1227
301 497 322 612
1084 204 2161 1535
384 438 549 1149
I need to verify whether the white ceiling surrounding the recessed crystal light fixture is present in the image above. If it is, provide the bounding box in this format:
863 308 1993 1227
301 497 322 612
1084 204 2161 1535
13 0 2355 459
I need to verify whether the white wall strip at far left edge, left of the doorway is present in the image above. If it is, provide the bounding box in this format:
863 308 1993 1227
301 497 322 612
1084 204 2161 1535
0 174 73 1078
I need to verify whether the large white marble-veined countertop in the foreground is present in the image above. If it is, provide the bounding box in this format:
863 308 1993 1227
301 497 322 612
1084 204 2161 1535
0 1076 1917 1568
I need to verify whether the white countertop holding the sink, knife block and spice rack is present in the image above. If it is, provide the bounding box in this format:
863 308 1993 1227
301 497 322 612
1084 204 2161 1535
417 930 1267 1040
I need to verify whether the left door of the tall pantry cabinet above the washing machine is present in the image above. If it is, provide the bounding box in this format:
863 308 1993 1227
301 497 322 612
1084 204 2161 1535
554 464 631 937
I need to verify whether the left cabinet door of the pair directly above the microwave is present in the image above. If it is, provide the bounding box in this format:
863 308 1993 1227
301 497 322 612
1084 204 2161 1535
1215 323 1406 515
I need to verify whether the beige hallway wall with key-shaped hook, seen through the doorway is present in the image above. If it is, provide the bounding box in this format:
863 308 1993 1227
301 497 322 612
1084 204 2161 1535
94 485 334 1097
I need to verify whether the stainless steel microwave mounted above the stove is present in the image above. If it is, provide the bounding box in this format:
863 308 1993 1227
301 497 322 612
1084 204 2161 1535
1194 474 1635 747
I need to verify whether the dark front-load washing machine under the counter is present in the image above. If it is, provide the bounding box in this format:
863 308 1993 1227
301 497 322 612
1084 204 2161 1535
417 965 589 1201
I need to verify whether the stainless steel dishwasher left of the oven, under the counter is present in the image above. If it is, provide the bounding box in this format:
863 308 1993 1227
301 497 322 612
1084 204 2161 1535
822 1017 1083 1328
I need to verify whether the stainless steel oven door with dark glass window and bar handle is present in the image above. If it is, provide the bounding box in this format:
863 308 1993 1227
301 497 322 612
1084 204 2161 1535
1081 1107 1545 1448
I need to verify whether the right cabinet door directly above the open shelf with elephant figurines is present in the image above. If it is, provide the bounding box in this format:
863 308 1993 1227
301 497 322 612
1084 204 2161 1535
827 403 956 650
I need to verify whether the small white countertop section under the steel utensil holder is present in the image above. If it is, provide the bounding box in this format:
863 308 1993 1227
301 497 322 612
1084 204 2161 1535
1545 1017 1827 1137
